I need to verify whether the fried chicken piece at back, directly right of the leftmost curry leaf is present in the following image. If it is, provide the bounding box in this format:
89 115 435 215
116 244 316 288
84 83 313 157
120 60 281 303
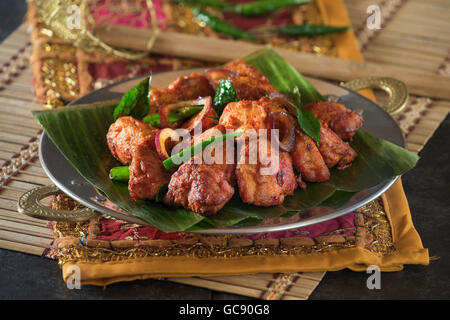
149 72 214 114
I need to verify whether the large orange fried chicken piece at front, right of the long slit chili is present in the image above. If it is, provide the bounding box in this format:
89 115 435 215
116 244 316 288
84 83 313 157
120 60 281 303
236 136 297 207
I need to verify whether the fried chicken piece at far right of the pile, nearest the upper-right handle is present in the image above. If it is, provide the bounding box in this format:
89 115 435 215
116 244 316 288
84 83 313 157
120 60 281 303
305 101 364 140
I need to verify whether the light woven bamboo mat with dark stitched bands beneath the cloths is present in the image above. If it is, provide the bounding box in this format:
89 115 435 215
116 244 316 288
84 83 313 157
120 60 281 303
0 0 450 299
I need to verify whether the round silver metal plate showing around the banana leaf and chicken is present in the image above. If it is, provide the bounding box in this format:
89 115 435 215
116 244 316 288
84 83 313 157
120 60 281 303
39 69 406 234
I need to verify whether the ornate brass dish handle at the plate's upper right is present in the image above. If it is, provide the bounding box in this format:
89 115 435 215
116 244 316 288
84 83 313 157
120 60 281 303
341 77 409 116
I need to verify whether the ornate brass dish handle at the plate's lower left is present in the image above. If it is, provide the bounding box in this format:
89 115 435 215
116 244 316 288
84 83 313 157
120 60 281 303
18 185 98 222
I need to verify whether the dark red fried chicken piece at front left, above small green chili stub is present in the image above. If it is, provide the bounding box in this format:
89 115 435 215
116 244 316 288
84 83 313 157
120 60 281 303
128 142 170 200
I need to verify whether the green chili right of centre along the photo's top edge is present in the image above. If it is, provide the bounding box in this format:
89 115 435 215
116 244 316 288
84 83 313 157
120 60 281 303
221 0 311 17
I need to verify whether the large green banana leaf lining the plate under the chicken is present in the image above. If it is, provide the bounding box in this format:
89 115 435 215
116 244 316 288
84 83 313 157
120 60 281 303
33 50 418 232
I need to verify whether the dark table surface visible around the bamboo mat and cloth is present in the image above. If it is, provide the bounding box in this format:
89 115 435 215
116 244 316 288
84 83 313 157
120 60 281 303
0 0 450 300
